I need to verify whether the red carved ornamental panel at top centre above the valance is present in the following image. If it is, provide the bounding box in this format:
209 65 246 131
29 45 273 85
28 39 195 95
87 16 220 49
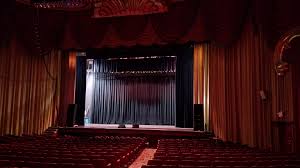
93 0 168 18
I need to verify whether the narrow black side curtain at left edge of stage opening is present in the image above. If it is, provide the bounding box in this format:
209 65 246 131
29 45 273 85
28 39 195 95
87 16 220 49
75 57 86 125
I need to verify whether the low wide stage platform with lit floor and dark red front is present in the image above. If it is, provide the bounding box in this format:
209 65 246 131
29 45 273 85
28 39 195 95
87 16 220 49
58 124 211 139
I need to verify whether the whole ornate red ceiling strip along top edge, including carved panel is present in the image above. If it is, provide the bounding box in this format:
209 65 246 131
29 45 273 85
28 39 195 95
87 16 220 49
16 0 184 18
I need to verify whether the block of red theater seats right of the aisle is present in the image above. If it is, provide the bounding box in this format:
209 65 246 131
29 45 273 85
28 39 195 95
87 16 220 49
143 139 300 168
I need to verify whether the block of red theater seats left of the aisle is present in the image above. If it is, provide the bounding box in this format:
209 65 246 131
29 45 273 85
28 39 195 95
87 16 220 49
0 136 146 168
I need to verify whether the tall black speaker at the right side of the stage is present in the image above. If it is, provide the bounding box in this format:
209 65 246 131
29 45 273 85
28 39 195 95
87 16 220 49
194 104 204 131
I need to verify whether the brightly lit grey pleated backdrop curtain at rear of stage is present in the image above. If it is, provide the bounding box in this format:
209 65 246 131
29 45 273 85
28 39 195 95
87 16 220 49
86 57 176 125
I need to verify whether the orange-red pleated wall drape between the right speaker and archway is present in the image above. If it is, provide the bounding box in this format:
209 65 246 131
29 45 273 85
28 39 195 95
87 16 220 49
204 23 272 149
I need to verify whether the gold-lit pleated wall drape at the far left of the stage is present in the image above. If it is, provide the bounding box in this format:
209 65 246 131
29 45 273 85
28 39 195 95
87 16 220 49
0 37 61 135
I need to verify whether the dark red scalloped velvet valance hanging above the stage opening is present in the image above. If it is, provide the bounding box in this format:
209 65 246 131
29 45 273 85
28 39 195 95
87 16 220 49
16 0 248 49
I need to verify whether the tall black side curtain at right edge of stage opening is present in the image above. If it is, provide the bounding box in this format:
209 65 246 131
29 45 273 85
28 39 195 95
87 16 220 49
176 45 194 128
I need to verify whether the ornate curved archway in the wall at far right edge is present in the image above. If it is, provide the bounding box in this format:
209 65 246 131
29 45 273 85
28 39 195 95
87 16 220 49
272 28 300 152
